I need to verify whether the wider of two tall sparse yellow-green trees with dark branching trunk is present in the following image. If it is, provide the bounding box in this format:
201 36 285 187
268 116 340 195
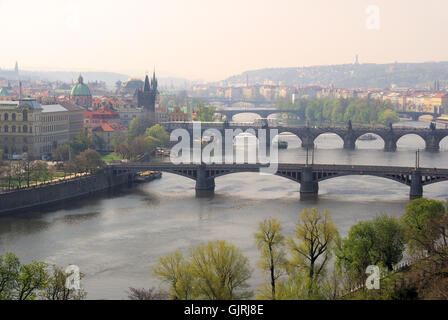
287 208 339 294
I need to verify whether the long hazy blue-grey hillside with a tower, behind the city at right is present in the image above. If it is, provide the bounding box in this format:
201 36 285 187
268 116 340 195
224 62 448 88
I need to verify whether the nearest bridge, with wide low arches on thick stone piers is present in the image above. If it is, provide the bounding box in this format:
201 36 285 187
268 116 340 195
109 163 448 200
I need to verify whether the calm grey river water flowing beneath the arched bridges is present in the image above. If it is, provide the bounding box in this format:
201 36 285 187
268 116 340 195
0 118 448 299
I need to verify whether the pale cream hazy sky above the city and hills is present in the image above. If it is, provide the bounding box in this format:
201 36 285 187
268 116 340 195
0 0 448 80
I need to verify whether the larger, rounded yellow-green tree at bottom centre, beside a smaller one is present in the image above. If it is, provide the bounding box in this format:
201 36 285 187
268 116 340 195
190 241 252 300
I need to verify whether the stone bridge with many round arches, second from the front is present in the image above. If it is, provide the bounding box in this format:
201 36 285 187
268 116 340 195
162 122 448 151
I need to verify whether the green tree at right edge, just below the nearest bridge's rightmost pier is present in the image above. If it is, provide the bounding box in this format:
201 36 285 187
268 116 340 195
401 198 448 253
